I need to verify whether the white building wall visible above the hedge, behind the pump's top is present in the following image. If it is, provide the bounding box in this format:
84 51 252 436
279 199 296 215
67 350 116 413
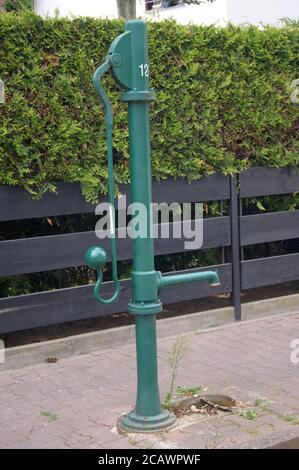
35 0 299 25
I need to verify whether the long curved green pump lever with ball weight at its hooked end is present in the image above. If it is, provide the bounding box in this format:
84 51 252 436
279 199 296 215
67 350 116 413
84 55 121 304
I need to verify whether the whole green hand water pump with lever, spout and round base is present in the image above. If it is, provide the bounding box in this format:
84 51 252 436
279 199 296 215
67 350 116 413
85 20 219 432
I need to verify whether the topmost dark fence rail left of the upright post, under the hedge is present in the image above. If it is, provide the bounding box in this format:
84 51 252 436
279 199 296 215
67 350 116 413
0 174 230 221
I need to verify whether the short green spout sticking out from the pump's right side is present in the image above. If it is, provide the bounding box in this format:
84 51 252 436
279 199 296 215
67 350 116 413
157 271 220 291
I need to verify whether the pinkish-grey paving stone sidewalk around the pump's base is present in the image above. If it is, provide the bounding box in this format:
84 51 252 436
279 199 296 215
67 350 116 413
0 312 299 449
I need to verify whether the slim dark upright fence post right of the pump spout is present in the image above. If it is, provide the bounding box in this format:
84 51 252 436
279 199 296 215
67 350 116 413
230 175 242 320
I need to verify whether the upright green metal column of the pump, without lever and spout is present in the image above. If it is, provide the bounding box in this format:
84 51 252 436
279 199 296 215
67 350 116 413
120 20 175 432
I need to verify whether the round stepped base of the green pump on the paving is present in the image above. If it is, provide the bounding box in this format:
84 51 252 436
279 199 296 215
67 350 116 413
117 409 176 434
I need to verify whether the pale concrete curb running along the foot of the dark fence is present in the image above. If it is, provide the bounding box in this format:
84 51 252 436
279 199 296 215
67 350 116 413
0 294 299 371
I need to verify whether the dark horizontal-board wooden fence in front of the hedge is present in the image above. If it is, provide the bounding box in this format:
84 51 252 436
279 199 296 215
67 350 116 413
0 168 299 333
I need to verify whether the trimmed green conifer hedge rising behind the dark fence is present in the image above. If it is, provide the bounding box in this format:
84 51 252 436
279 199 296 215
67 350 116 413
0 13 299 200
